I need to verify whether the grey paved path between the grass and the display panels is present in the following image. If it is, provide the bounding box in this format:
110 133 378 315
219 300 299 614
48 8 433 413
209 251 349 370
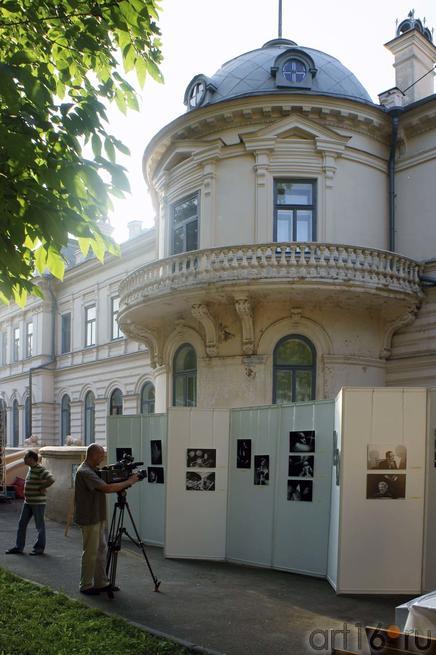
0 501 405 655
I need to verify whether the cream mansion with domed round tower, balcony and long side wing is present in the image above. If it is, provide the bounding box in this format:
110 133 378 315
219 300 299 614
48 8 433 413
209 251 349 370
0 14 436 445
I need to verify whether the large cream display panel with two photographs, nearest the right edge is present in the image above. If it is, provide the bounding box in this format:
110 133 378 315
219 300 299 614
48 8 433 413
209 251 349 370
329 388 426 594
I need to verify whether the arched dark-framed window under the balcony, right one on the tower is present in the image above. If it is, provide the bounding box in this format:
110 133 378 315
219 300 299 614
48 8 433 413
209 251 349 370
273 334 316 404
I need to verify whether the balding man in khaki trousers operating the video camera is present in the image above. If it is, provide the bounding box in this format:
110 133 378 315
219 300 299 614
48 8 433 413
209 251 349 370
74 443 139 596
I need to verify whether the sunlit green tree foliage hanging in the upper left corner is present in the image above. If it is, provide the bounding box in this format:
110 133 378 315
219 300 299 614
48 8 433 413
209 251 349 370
0 0 161 304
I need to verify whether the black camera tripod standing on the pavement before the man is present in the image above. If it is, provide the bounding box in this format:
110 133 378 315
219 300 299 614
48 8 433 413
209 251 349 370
106 490 161 598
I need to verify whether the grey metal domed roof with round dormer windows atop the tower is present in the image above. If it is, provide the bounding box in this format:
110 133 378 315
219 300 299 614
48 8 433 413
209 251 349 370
185 38 372 110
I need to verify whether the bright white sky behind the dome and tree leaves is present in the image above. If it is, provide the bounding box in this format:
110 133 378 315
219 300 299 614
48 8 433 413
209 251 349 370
105 0 436 242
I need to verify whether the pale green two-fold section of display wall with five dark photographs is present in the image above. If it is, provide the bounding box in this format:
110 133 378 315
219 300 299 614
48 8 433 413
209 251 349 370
227 401 334 576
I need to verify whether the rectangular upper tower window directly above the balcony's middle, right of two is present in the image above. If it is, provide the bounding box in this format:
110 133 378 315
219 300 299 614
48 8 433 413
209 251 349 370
274 180 316 243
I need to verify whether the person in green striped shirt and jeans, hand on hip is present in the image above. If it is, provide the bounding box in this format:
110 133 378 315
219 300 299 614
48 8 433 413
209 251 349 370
6 450 55 555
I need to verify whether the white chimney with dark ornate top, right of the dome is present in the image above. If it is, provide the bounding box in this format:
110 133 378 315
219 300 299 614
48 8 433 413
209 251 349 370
385 11 436 105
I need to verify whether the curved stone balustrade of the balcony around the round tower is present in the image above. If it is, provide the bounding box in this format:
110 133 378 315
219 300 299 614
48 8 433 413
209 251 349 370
120 243 421 307
